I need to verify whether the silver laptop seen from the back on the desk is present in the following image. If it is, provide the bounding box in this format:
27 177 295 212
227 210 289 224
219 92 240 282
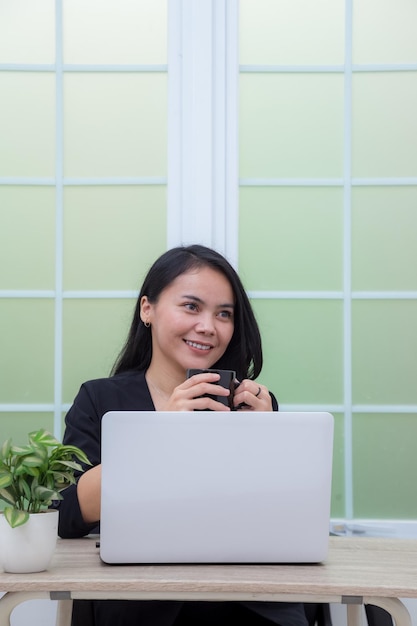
100 411 334 563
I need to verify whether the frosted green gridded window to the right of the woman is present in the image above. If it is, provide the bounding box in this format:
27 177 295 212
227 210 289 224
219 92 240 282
239 0 417 519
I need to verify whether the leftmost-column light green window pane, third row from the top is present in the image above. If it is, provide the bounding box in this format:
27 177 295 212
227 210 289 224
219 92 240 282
0 186 55 289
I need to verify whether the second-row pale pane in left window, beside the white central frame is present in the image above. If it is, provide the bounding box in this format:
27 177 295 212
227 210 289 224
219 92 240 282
64 73 167 177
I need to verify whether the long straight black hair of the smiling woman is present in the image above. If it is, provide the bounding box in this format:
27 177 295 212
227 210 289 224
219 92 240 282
111 245 263 380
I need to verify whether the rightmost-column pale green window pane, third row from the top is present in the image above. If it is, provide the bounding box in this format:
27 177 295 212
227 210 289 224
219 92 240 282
352 187 417 291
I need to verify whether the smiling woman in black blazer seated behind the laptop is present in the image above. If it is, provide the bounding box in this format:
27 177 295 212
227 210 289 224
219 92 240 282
59 245 306 626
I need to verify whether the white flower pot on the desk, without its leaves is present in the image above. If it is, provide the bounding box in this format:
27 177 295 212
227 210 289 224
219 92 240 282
0 510 58 574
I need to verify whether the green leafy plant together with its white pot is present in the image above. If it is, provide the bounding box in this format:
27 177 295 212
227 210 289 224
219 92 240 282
0 429 91 572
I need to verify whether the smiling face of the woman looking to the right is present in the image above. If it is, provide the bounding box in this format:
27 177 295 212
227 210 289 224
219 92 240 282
141 267 235 377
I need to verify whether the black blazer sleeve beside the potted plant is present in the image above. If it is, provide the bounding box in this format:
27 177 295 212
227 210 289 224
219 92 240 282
55 385 101 539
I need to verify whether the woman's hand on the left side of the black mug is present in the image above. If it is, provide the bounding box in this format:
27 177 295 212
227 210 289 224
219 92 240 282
164 372 230 411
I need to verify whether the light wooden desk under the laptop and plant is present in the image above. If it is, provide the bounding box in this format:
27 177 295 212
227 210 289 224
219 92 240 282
0 537 417 626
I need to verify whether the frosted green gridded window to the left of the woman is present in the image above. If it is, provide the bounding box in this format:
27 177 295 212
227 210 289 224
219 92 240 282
0 0 168 441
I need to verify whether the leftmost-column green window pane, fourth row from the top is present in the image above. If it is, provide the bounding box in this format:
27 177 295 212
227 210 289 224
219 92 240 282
0 299 54 403
